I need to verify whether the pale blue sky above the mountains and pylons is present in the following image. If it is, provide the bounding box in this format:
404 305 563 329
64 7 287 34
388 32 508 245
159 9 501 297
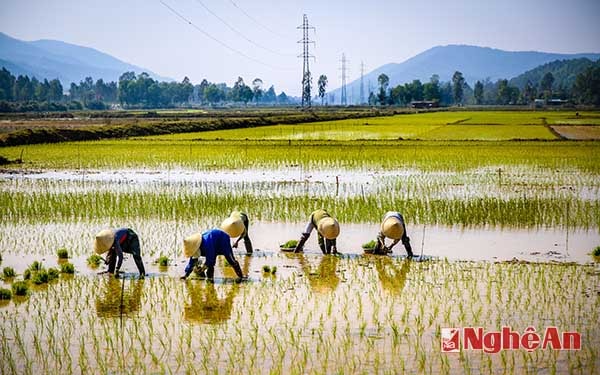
0 0 600 95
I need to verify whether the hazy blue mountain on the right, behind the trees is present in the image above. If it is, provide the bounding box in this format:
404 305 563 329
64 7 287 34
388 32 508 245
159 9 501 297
332 45 600 104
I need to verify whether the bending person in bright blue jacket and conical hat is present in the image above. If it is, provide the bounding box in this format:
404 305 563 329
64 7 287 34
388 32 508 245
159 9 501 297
181 228 246 281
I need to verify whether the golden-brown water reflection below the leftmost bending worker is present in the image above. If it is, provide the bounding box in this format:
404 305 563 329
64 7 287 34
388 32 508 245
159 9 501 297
96 276 144 318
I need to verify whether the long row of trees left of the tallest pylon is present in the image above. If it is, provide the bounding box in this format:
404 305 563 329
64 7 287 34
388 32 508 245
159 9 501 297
0 68 291 112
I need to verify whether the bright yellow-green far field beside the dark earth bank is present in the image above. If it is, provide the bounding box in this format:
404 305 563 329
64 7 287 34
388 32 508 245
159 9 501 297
144 111 600 140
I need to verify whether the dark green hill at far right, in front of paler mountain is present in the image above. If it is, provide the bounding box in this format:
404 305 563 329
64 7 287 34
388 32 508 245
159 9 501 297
509 58 594 89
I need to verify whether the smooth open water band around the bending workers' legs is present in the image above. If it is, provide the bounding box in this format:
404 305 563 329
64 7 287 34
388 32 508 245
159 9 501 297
0 220 600 282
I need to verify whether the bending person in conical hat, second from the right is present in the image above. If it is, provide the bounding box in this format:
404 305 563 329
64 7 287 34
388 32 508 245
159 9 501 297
294 209 340 254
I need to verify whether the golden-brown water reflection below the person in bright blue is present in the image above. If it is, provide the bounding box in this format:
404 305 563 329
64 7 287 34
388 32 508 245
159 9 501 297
183 280 239 324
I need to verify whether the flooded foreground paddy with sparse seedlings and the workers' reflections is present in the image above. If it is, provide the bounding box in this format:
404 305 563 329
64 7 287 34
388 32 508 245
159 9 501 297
0 253 600 374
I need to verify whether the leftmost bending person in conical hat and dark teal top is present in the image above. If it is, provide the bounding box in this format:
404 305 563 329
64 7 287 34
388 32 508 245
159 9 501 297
94 228 146 277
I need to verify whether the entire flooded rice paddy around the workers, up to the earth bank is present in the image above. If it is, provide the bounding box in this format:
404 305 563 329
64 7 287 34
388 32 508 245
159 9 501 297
0 111 600 374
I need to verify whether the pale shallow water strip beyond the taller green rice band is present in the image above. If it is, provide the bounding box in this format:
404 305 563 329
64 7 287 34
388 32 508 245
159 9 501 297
0 166 600 201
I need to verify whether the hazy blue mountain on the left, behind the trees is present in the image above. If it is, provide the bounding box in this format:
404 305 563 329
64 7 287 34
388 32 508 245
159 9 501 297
0 33 171 89
